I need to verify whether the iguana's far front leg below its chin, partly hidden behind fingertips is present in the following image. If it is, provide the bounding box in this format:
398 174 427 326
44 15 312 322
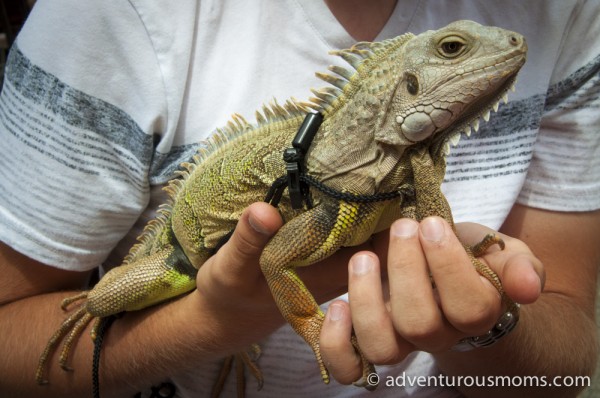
410 147 518 316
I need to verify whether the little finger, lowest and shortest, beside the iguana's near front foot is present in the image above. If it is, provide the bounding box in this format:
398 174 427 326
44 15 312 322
319 300 362 384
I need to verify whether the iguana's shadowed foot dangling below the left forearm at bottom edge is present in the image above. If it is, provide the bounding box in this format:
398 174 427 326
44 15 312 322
210 344 264 398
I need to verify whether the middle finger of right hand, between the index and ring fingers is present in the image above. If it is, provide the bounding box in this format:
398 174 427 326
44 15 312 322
387 219 462 352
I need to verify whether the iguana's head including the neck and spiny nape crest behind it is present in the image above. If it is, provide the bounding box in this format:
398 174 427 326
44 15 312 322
316 21 527 155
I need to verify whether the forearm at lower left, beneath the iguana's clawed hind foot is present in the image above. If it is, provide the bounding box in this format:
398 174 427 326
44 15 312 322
0 292 236 398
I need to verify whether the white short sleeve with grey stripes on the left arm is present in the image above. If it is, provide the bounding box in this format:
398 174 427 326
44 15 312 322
0 0 165 270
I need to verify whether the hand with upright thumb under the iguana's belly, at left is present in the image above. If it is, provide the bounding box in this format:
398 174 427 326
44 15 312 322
186 203 356 356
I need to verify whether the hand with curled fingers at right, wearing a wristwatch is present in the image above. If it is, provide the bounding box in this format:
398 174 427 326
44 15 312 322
320 217 544 384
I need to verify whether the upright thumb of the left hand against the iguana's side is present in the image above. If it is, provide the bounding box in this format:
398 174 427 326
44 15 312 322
198 203 283 288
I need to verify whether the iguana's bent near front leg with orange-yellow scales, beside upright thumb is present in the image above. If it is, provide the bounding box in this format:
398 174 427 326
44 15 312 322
260 201 382 387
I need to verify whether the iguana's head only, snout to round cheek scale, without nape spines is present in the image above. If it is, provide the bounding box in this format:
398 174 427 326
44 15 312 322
390 21 527 152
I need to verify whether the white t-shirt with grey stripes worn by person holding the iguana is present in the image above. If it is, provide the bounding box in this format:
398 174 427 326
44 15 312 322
0 0 600 397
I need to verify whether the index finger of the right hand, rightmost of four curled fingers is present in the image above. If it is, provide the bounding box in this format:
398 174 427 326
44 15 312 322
420 217 501 335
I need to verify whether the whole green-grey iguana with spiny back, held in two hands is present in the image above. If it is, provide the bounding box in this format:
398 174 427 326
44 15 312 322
36 21 527 394
